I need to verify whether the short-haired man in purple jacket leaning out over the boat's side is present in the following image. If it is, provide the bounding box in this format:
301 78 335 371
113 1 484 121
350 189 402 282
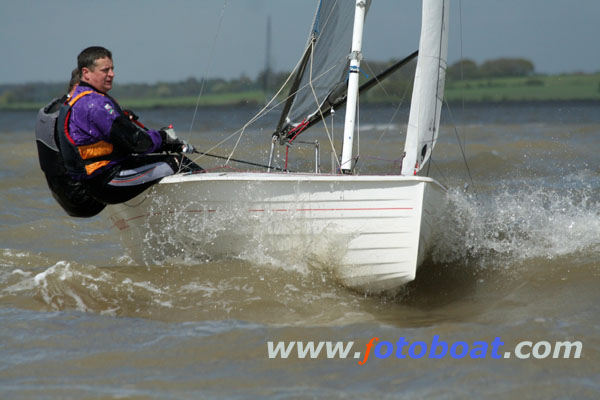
57 46 202 204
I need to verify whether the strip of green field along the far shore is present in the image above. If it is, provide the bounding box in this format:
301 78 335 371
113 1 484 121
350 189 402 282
0 73 600 110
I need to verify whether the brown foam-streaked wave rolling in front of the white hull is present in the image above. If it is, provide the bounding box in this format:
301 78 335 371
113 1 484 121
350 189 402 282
0 250 370 325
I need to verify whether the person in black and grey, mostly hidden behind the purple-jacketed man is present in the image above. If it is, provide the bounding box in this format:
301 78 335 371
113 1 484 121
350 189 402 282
35 68 106 218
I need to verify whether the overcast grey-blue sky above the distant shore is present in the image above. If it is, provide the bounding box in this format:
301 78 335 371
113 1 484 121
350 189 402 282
0 0 600 83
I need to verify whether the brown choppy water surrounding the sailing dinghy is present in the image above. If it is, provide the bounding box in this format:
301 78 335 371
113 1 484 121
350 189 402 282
0 104 600 399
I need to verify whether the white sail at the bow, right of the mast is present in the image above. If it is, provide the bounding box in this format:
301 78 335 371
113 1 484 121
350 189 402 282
402 0 450 175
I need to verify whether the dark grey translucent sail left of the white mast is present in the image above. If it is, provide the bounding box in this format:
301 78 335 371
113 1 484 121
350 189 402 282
278 0 371 137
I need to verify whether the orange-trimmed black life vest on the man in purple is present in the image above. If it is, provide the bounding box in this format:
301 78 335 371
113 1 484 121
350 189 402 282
57 90 115 177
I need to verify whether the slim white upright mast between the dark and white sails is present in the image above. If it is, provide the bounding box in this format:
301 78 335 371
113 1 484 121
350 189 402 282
341 0 367 174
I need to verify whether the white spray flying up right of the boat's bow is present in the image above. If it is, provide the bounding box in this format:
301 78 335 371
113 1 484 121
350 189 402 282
434 177 600 265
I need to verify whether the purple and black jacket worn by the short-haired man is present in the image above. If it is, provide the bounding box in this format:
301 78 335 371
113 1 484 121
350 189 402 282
69 83 162 175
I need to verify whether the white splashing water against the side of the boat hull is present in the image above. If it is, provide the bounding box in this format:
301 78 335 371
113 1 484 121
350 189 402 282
133 188 351 274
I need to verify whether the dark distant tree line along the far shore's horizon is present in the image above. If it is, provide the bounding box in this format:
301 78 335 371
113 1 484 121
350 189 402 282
0 58 535 106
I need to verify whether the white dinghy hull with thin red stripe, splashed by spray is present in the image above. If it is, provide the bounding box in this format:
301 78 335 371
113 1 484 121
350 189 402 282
109 173 445 293
